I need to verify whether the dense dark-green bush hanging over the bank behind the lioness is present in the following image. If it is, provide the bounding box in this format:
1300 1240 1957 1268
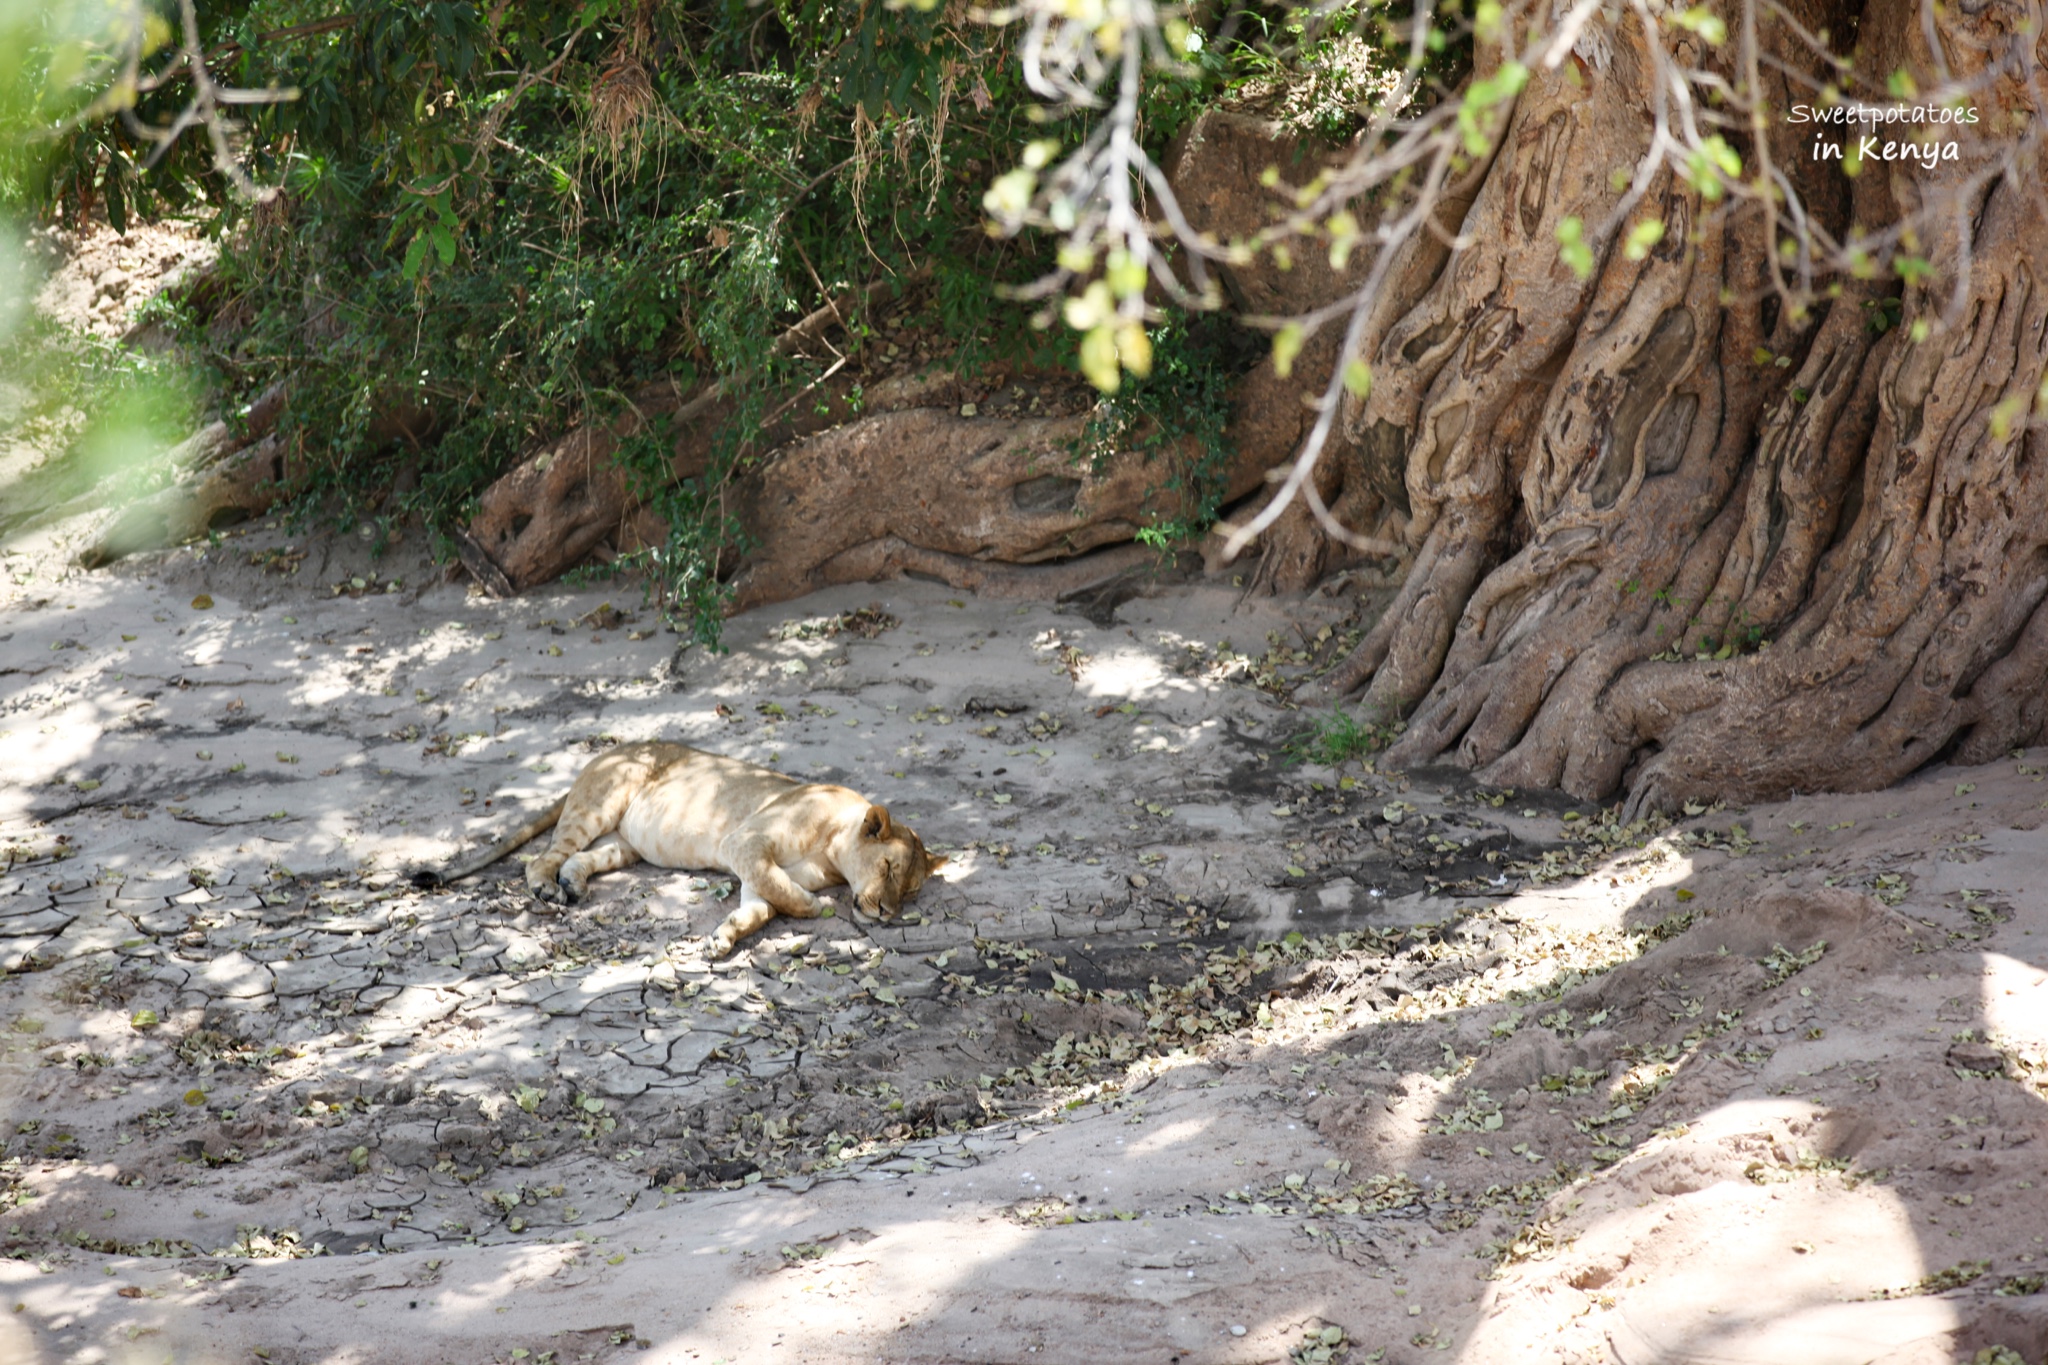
178 0 1042 641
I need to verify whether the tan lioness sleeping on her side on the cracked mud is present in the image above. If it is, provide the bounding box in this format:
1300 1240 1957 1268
414 743 946 958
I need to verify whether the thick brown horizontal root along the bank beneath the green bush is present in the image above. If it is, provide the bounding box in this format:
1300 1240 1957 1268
457 286 1272 610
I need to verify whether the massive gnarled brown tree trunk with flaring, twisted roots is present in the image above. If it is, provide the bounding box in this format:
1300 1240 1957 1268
1266 0 2048 808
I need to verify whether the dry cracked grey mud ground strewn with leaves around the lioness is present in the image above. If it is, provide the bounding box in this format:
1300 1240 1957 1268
0 532 2048 1365
